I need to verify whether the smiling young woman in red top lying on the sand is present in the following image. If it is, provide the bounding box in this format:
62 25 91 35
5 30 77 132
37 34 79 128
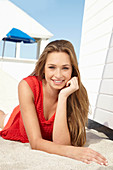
0 40 107 165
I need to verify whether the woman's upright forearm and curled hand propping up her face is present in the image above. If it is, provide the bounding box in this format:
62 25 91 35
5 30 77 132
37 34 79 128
53 77 79 145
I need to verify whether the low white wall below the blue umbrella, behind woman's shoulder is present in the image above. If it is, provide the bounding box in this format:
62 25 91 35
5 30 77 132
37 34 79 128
0 58 36 113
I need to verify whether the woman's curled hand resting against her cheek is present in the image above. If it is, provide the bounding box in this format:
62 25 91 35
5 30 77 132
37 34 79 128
60 77 79 97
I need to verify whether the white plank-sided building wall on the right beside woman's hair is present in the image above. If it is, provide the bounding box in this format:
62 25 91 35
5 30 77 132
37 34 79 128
79 0 113 129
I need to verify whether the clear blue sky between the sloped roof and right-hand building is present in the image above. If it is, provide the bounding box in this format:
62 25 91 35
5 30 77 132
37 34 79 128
0 0 85 61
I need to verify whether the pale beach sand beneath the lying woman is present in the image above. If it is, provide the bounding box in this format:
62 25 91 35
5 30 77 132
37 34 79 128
0 129 113 170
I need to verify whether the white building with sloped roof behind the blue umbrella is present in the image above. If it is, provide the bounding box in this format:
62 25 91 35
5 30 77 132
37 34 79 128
0 0 53 112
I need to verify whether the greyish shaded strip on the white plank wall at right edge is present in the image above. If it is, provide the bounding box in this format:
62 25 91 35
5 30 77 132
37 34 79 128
94 29 113 129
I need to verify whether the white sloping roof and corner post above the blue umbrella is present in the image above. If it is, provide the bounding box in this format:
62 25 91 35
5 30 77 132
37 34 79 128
0 0 53 58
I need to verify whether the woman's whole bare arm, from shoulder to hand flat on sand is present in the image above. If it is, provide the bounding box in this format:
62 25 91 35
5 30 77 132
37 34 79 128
18 80 106 164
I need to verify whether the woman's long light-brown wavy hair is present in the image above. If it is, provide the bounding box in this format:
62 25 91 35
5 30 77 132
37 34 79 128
31 40 89 146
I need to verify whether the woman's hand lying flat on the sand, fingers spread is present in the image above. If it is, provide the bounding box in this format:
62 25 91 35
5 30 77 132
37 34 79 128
71 147 108 166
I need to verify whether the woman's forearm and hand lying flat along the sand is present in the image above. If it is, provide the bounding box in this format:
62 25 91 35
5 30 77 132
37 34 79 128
32 138 107 165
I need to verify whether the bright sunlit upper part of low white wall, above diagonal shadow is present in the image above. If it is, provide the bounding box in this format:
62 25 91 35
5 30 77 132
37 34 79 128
0 58 36 82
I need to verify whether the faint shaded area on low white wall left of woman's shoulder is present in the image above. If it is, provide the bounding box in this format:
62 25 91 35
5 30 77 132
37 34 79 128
0 69 18 113
